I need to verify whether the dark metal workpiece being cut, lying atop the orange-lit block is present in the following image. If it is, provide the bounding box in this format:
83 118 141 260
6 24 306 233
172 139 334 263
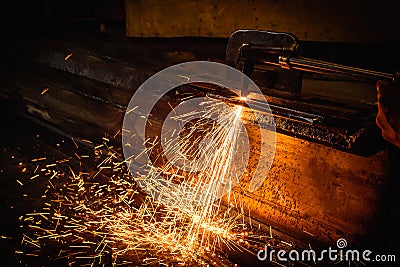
206 92 384 156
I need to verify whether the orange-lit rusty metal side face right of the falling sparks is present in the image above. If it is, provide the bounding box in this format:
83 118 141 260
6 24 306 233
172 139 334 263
228 127 389 247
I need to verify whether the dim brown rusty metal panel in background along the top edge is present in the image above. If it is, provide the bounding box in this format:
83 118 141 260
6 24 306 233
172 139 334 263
125 0 400 42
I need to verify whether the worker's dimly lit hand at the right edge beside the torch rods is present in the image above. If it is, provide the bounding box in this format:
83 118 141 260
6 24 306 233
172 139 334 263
376 81 400 148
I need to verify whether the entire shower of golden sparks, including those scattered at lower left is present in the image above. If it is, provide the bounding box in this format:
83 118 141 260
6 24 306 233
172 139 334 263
21 101 260 265
